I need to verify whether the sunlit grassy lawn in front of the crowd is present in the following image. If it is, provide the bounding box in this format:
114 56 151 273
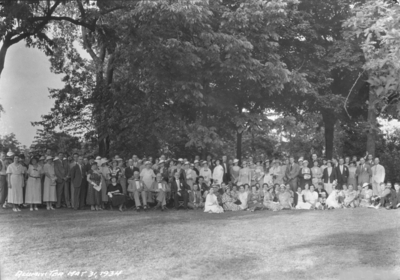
0 209 400 280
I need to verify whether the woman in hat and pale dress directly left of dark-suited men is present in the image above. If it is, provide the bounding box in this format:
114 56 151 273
43 156 57 210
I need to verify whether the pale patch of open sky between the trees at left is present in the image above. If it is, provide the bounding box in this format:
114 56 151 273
0 41 63 147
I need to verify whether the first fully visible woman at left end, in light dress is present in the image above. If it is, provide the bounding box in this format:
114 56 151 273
7 155 26 212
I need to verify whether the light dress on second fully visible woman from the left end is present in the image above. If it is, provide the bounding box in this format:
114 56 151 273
25 165 43 204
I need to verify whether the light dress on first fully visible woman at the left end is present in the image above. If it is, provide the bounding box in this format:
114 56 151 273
7 162 26 204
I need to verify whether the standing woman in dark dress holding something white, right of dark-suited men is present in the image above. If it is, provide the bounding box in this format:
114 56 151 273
86 162 103 211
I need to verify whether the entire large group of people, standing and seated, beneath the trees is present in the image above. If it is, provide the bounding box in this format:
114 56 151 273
0 149 400 213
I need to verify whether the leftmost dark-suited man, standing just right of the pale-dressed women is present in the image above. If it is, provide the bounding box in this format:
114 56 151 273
54 152 71 208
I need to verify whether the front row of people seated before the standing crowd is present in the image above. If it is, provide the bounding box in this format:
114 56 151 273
122 172 400 213
